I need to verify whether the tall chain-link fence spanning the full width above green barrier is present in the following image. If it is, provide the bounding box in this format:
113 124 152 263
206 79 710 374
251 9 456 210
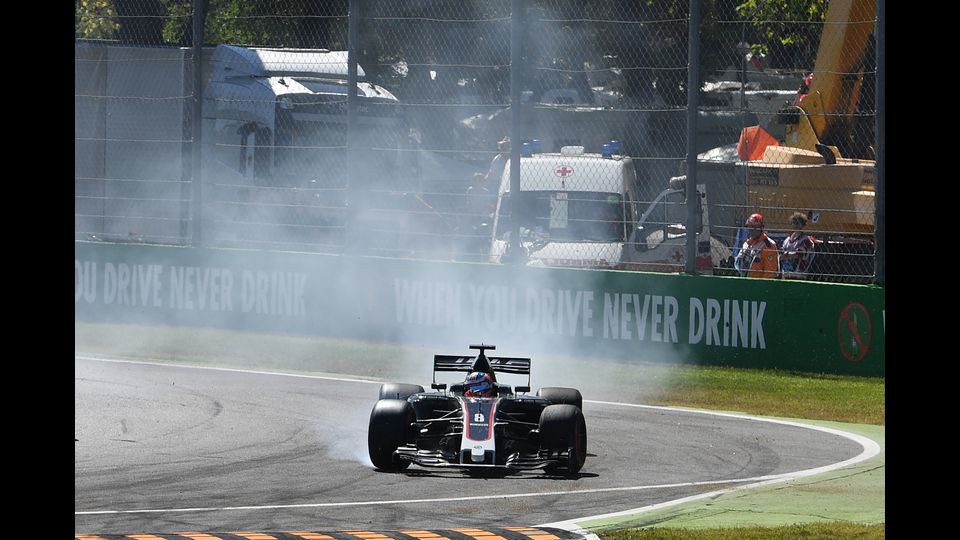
75 0 882 282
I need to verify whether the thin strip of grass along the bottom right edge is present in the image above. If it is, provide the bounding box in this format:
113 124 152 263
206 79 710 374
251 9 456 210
600 523 886 540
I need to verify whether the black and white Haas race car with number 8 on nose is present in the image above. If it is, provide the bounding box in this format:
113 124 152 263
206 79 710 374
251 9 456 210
367 345 587 475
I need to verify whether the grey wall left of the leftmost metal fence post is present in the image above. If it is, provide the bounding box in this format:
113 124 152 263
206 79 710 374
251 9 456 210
74 42 192 243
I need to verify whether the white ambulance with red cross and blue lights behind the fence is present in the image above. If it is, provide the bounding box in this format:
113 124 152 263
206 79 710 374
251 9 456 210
489 146 731 273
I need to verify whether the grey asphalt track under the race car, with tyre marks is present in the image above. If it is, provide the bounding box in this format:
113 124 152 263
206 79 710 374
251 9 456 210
74 358 863 534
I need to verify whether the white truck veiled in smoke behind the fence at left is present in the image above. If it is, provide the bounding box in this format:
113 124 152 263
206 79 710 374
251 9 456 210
204 45 407 186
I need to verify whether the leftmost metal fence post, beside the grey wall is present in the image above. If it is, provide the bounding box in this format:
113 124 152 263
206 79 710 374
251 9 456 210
190 0 207 247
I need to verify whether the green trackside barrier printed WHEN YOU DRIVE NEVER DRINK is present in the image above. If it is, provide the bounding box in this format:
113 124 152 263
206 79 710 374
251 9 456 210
74 242 885 376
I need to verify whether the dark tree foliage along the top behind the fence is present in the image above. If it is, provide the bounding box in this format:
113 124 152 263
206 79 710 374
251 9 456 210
82 0 827 97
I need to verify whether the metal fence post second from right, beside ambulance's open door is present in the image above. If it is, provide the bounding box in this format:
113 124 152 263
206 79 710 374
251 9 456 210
685 0 710 274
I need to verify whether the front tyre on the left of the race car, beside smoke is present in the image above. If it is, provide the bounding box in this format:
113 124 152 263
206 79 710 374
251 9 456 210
367 399 416 471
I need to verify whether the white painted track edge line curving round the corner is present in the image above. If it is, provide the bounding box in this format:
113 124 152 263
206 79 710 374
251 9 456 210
74 354 880 520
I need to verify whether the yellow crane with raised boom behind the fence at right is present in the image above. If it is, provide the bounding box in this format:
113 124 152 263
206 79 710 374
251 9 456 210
741 0 876 275
